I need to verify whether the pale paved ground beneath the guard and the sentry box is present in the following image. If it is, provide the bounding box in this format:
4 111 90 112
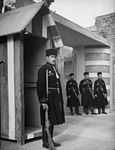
2 109 115 150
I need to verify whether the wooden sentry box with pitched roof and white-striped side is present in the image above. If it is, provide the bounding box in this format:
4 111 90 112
0 1 60 143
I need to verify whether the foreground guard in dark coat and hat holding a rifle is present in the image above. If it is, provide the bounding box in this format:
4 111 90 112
37 48 65 148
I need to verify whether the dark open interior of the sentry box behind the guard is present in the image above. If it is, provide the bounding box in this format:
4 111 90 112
24 34 46 133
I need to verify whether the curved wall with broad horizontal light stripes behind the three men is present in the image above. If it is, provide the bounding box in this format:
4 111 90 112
85 48 110 100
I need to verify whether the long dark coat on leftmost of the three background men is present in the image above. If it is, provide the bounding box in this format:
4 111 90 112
66 79 80 107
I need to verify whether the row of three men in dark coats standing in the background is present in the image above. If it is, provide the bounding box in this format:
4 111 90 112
66 72 108 115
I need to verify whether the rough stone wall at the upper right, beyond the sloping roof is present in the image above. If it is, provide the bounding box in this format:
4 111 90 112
95 13 115 110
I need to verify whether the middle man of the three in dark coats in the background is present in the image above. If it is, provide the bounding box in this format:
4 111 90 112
79 72 95 115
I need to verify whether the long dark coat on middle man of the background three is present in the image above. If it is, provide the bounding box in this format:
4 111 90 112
79 79 94 107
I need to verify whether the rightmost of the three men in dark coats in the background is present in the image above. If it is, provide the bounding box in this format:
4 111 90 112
94 72 108 114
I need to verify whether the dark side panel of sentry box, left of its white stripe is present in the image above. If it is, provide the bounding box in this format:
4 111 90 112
0 37 9 138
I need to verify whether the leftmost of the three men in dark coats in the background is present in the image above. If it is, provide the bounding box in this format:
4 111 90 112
66 73 81 115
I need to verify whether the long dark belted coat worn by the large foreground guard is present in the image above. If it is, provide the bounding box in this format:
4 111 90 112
37 63 65 125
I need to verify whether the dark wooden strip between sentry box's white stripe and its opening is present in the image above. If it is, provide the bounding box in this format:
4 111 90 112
14 34 24 141
